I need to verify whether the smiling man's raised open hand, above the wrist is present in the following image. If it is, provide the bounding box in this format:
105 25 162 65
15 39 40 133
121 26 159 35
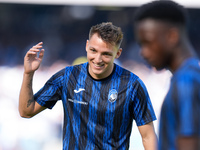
24 42 44 74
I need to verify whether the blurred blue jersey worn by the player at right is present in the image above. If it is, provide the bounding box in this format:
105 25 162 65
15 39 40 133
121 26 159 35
159 58 200 150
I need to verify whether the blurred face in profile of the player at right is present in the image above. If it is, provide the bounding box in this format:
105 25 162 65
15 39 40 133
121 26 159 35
135 19 171 70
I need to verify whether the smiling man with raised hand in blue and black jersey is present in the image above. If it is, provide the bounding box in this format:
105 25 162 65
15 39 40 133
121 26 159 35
19 23 157 150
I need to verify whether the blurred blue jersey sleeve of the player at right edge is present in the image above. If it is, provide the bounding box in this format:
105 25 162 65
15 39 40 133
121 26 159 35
172 74 200 136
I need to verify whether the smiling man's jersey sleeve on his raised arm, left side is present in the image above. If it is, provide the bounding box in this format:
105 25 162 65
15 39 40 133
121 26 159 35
34 69 65 109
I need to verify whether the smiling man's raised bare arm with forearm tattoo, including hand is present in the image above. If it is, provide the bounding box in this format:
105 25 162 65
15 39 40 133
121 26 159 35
19 42 45 118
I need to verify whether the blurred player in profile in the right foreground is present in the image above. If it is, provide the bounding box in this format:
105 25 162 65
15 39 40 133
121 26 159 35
134 1 200 150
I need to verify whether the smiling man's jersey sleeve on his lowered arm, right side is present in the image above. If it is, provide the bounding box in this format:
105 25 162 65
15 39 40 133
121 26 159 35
132 78 156 126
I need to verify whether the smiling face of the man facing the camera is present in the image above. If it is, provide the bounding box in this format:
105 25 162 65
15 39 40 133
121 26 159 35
86 34 122 79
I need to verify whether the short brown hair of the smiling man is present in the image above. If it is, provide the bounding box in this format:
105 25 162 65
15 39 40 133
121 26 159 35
89 22 123 47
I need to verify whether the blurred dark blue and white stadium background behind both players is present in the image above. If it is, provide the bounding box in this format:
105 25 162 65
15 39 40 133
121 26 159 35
0 0 200 150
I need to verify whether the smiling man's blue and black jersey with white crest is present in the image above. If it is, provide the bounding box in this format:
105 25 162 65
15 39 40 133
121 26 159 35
35 63 156 150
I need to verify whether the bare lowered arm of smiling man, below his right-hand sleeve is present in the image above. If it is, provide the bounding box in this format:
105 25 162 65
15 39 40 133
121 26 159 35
138 122 158 150
